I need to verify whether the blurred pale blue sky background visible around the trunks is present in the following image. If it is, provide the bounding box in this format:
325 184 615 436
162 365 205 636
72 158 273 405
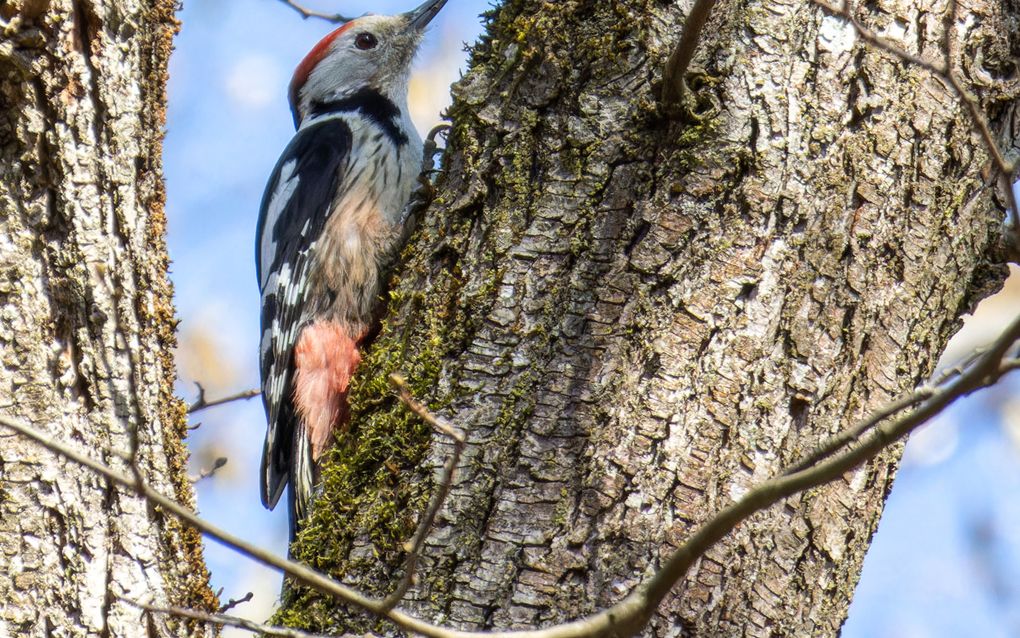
164 0 1020 638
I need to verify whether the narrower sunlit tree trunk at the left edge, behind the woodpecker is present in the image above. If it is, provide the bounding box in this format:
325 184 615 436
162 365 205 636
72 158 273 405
0 0 214 636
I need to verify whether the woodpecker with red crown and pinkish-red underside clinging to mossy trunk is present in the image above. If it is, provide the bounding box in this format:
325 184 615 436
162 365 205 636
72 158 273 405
255 0 446 537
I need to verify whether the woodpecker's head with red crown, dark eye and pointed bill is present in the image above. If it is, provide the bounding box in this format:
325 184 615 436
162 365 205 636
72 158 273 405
290 0 447 126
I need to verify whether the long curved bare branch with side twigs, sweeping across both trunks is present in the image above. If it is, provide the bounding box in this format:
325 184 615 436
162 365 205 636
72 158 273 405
0 317 1020 638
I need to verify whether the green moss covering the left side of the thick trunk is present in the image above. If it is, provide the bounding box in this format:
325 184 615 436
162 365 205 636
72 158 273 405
272 0 734 632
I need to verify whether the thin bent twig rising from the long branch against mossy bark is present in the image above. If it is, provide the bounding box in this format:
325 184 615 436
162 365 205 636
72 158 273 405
383 375 465 610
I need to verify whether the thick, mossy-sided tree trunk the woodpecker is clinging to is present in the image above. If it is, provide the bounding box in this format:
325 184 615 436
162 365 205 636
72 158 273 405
276 0 1020 636
